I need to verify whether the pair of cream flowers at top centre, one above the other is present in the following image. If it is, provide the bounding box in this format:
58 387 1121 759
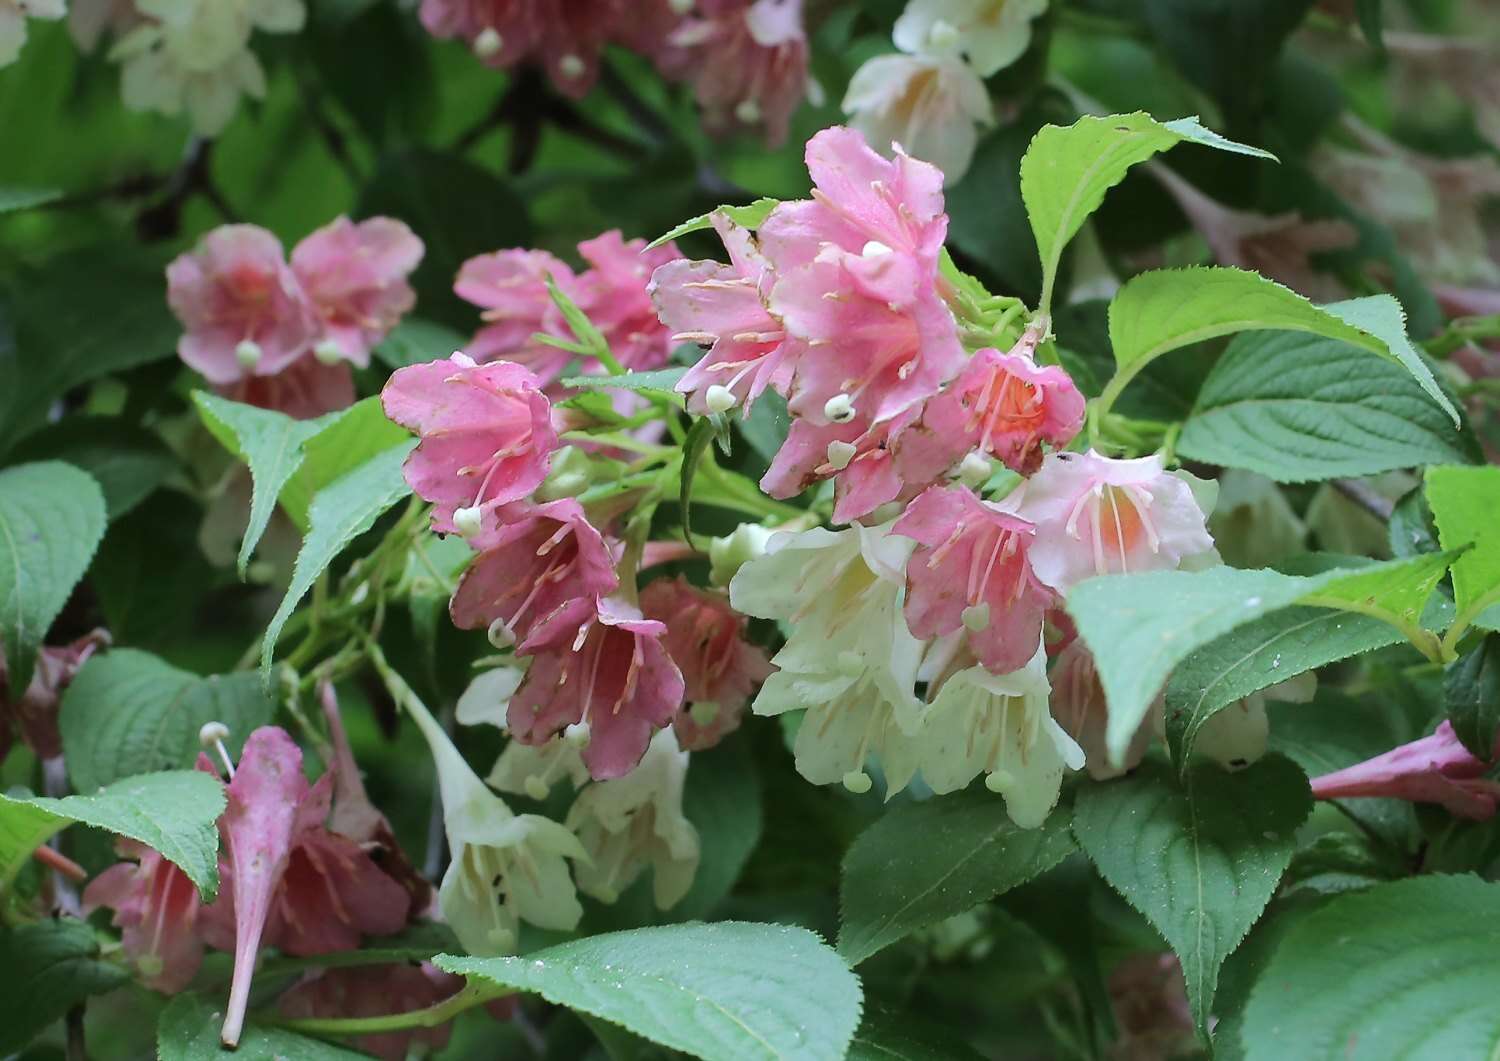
843 0 1047 180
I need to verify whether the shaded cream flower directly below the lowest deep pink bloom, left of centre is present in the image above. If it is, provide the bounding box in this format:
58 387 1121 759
567 729 698 909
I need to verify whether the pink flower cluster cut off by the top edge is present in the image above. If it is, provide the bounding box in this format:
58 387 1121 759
422 0 810 144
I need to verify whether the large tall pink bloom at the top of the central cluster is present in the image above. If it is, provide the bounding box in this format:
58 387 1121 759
759 128 965 423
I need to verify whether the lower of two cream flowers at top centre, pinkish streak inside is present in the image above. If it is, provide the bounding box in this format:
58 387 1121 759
843 54 995 185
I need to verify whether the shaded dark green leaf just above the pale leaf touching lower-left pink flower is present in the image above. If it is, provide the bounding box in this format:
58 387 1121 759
59 648 272 792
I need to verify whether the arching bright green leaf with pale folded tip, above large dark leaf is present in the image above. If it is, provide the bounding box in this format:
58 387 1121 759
1104 266 1460 426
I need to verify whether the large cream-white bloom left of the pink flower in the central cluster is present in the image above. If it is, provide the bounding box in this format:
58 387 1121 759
729 524 926 791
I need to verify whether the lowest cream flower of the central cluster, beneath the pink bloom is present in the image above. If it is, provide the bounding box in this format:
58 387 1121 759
918 638 1085 828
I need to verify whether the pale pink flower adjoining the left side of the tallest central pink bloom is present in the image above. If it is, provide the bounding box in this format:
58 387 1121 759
648 213 792 416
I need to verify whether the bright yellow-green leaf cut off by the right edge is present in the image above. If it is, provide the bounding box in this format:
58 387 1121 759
1427 465 1500 636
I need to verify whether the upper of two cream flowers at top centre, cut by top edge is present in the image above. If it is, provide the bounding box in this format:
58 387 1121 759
893 0 1047 78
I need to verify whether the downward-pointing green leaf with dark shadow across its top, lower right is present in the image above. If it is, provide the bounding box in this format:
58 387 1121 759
1073 755 1323 1056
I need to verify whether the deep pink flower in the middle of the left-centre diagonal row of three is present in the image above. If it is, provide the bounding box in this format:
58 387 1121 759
449 498 620 651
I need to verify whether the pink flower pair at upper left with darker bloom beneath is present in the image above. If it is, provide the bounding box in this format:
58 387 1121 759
167 218 423 417
